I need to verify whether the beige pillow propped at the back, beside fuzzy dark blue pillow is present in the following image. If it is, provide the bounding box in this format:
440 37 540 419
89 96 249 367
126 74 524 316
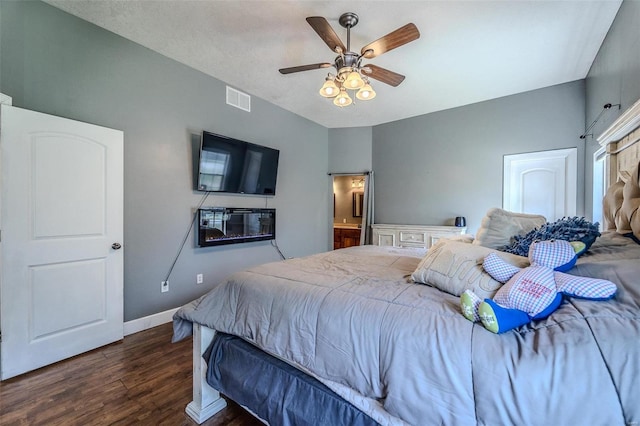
473 208 547 249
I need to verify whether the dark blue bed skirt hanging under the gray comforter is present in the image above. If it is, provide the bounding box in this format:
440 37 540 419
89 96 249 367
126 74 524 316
203 333 378 426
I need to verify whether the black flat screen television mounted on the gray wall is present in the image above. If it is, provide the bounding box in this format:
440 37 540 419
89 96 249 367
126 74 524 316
196 131 280 195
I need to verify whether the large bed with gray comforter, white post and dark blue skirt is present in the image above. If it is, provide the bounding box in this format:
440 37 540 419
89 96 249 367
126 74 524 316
174 98 640 425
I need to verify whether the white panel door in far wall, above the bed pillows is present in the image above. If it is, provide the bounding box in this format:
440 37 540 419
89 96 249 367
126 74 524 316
503 148 578 222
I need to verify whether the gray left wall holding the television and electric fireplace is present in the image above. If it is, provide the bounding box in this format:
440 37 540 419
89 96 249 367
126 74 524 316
0 2 331 321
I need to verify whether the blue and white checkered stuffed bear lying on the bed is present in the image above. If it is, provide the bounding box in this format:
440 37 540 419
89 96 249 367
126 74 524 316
460 240 616 333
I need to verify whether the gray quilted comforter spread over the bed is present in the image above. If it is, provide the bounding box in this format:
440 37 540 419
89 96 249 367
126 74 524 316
174 238 640 425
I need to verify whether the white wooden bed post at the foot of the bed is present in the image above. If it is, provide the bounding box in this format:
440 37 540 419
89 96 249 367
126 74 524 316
185 323 227 424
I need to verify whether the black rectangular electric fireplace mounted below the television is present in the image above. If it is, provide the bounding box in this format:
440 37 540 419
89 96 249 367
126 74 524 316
198 207 276 247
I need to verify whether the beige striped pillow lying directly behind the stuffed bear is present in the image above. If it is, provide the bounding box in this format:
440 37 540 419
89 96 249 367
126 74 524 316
411 240 529 299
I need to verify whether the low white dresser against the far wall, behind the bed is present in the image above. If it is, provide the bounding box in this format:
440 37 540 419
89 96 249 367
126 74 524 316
371 223 467 248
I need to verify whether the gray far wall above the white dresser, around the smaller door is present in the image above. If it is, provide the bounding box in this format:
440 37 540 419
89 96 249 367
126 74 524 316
373 80 584 233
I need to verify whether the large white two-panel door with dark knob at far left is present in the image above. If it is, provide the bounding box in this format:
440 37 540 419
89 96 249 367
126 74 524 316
0 105 123 379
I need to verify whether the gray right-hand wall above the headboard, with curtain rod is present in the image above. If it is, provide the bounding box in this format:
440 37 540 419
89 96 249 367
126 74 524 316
585 0 640 217
